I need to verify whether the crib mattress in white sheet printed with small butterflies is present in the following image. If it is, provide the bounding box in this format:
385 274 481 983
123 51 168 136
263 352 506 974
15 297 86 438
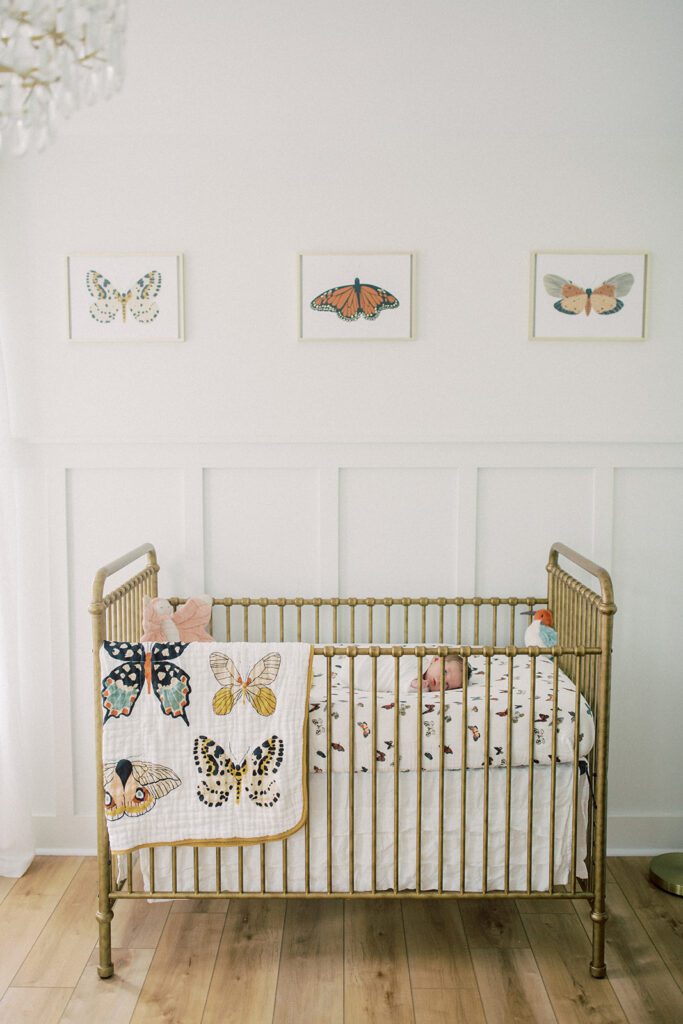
308 655 595 774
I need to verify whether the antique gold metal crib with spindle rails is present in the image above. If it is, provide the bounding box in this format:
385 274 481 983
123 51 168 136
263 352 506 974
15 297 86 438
89 544 616 978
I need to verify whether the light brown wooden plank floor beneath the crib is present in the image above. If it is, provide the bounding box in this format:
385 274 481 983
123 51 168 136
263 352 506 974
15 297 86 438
0 857 683 1024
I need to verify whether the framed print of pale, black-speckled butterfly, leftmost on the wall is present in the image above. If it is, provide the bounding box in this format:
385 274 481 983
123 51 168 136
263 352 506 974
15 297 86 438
67 253 183 342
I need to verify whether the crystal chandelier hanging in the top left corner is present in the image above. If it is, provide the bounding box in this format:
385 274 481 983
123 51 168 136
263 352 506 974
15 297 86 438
0 0 126 155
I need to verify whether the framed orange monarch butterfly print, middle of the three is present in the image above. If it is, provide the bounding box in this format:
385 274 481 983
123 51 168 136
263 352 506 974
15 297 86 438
299 253 415 341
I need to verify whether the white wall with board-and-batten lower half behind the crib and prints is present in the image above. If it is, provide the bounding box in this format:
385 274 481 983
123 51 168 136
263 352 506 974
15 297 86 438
0 0 683 849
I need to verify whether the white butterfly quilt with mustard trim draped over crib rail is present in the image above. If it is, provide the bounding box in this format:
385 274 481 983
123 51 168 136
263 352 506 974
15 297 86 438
100 641 312 853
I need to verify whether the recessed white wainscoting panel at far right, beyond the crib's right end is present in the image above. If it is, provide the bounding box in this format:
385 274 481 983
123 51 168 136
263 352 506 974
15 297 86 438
610 468 683 819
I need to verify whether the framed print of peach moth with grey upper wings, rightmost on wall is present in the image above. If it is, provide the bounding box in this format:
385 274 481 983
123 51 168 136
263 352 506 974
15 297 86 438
529 252 648 341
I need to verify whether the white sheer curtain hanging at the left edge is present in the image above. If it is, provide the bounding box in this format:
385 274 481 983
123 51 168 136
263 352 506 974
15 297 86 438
0 339 34 878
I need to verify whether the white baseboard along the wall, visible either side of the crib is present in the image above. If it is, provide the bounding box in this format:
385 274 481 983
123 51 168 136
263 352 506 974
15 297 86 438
34 814 683 857
